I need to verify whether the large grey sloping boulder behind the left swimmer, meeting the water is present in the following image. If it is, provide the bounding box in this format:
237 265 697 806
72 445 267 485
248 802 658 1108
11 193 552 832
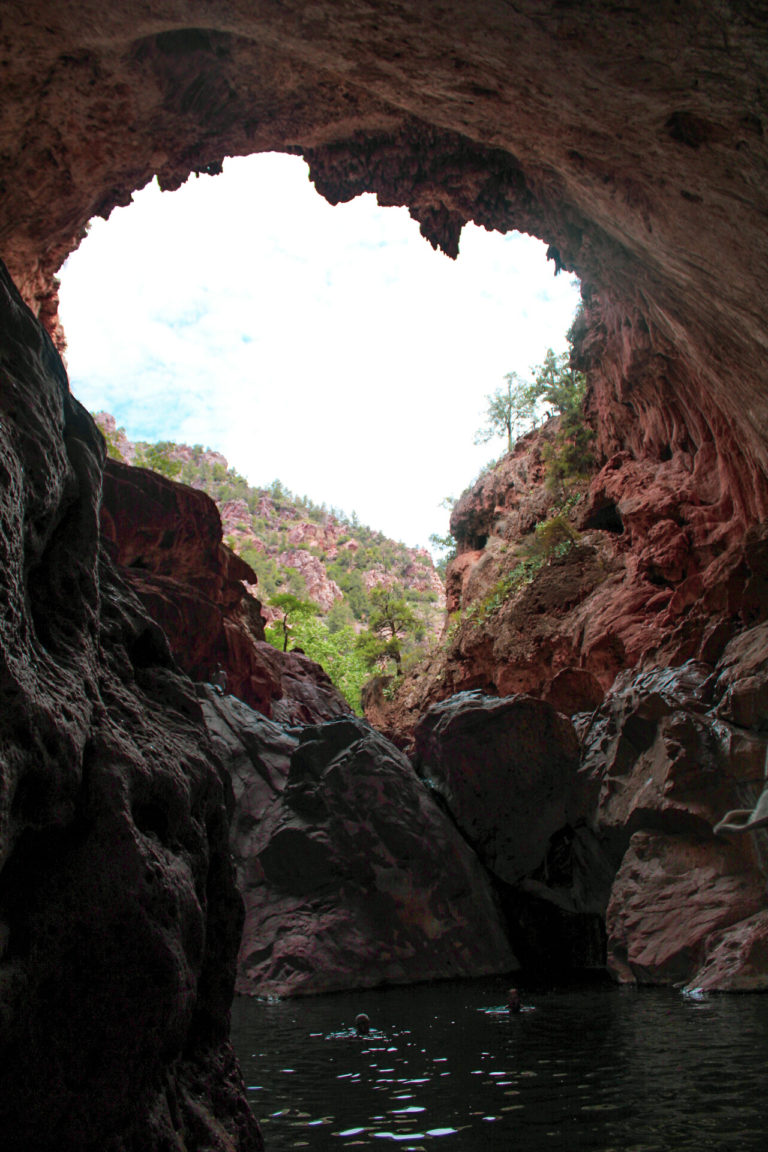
204 695 517 995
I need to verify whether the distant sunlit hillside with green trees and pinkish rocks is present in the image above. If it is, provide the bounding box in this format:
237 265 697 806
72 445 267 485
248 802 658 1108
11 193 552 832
94 412 444 712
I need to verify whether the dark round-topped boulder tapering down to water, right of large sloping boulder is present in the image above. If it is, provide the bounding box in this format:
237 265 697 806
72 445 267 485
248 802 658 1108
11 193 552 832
416 692 614 976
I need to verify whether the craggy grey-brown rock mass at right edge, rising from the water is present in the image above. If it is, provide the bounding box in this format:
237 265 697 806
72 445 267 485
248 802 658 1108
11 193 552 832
583 658 768 990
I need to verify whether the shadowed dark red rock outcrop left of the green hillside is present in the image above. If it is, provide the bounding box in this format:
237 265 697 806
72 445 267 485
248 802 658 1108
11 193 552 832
100 460 350 723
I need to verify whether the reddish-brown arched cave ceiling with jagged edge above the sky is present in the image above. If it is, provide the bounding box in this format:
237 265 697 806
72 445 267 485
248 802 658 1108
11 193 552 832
0 0 768 471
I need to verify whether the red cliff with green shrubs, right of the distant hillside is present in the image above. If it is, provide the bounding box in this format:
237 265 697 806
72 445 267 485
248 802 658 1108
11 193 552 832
382 410 768 742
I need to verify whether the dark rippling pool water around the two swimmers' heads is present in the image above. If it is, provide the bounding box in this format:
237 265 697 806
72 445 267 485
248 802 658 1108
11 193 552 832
233 980 768 1152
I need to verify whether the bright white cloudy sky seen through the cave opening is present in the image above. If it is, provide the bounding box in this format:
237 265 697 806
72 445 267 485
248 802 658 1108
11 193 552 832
61 154 578 545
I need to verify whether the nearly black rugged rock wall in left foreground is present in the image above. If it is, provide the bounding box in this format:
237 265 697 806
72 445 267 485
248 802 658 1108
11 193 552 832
0 270 261 1152
